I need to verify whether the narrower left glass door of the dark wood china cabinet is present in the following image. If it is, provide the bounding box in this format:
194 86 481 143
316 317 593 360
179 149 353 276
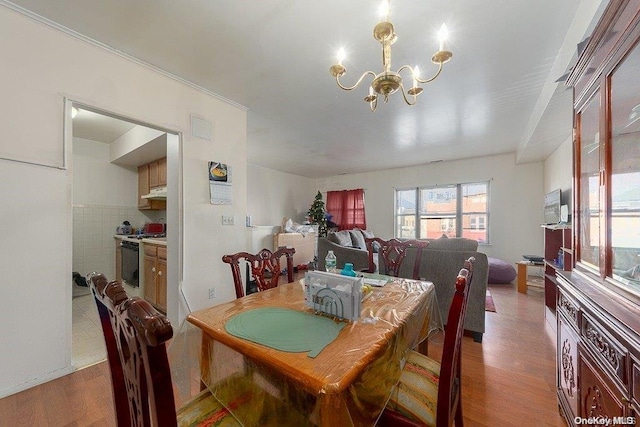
578 92 600 270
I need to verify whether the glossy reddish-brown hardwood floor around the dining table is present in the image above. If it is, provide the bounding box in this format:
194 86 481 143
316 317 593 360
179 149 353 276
0 285 566 427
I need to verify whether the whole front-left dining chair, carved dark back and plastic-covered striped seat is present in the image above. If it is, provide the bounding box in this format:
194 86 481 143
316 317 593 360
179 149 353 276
88 273 296 427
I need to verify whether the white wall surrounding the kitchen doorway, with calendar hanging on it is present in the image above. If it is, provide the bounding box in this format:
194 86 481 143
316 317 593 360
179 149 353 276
0 5 247 397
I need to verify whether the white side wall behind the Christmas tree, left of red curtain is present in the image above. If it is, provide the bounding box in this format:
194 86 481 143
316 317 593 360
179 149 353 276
247 165 317 226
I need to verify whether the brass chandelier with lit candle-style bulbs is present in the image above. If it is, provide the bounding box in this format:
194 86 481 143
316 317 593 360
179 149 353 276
329 0 453 111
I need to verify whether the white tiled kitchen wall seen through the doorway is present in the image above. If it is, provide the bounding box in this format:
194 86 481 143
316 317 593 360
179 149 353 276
73 204 166 280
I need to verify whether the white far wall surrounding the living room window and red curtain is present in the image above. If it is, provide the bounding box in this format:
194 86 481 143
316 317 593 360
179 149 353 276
318 154 544 263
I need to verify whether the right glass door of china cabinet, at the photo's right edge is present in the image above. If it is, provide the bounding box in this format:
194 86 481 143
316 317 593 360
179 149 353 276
610 41 640 291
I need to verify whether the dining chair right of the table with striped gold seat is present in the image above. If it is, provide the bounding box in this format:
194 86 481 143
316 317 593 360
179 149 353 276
378 257 475 427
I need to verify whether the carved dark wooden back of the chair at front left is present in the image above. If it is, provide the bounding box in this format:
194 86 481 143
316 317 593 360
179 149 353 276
89 273 177 427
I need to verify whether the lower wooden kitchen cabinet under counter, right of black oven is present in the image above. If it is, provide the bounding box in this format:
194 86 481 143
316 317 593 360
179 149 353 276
143 243 167 313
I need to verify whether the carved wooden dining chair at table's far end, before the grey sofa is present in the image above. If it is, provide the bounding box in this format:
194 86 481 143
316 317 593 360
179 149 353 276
364 237 429 280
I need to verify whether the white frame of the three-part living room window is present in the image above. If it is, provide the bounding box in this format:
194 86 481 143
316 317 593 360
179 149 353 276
393 180 491 246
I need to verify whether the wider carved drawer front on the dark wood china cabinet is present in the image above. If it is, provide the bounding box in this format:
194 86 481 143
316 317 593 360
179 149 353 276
582 314 629 385
